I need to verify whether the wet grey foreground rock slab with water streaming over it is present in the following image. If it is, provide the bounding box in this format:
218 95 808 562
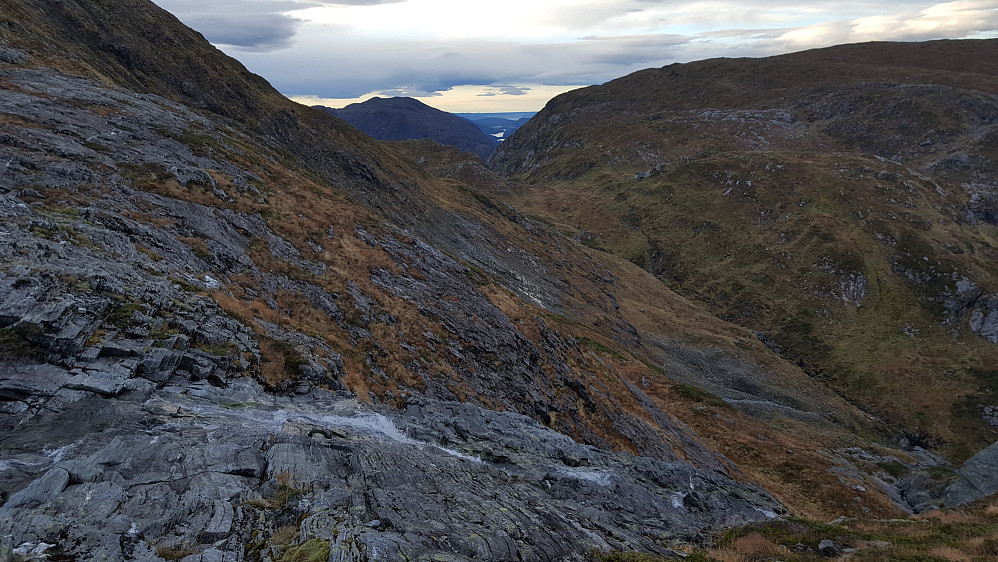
0 348 780 560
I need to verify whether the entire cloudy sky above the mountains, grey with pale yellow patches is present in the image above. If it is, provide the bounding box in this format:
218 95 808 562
154 0 998 112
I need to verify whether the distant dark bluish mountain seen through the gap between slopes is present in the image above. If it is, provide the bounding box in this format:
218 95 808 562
322 97 497 160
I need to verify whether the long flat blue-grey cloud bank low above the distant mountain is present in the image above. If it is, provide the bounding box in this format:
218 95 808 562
230 33 704 98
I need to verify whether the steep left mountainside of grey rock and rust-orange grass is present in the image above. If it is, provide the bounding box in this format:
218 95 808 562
0 0 998 562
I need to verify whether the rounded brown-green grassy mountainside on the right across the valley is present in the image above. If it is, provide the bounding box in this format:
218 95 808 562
489 40 998 459
